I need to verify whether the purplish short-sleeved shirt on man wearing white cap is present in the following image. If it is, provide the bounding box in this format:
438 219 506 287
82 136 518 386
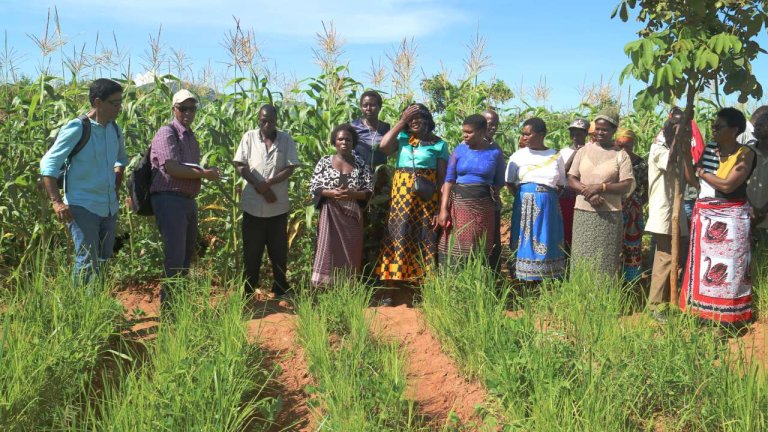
149 119 200 197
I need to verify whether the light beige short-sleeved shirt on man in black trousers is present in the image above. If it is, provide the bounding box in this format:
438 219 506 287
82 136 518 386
234 129 301 218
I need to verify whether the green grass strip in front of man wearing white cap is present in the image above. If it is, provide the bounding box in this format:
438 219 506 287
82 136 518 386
75 275 277 431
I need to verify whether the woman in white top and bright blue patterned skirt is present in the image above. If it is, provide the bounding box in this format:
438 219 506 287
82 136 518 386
506 117 566 281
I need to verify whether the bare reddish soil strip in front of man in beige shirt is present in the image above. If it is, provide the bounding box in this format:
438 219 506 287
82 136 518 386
248 305 312 431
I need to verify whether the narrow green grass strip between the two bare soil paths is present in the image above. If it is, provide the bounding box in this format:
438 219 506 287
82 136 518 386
297 276 423 432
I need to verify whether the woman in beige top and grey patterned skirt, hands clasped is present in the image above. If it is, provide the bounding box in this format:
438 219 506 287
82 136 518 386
568 112 634 277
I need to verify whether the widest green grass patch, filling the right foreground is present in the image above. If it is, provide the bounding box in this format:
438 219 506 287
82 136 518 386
423 256 768 431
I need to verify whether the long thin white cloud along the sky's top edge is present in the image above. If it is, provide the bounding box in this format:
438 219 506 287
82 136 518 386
33 0 465 44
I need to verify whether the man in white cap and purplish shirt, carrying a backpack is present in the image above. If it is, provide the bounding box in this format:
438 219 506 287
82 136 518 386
150 90 219 307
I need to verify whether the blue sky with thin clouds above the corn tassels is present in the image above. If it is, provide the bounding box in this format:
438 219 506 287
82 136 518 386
0 0 768 109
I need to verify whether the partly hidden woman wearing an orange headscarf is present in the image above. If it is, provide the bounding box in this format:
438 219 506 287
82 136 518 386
615 129 648 282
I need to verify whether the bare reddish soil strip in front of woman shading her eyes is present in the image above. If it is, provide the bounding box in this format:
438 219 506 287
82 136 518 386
374 306 487 426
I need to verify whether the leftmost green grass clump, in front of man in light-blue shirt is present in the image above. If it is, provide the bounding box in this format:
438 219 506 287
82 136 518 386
0 250 123 430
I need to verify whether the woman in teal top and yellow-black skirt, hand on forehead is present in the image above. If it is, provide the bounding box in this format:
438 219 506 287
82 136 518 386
376 104 448 305
